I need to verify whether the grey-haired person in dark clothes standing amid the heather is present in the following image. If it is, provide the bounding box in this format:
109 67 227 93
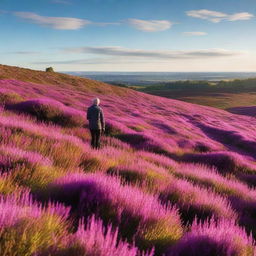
87 98 105 149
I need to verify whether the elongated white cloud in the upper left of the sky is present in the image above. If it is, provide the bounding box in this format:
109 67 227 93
14 12 92 30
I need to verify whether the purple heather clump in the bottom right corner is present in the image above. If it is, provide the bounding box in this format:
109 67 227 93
167 219 256 256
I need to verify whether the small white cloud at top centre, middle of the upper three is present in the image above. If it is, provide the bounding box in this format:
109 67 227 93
127 19 173 32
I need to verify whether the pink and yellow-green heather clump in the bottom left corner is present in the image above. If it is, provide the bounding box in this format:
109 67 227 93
0 193 69 256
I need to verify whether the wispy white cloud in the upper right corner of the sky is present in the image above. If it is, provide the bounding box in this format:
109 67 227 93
186 9 254 23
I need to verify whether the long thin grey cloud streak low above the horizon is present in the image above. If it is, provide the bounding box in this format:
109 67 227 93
64 46 244 59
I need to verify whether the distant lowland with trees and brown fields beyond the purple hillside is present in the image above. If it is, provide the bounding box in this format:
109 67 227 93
76 72 256 110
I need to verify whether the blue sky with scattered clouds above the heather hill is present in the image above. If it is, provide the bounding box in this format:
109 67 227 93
0 0 256 72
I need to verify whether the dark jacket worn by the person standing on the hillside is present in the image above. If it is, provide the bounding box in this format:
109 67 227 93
87 105 105 130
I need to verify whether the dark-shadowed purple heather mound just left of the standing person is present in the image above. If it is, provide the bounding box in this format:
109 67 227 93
9 98 85 127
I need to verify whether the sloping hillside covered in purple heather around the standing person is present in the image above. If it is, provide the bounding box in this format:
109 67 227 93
0 66 256 256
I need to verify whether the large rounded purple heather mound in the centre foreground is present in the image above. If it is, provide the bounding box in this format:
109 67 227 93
49 174 183 253
